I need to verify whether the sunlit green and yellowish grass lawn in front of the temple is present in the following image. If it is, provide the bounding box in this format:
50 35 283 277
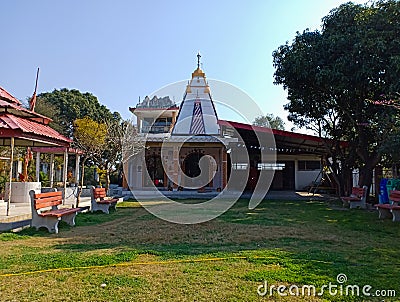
0 200 400 301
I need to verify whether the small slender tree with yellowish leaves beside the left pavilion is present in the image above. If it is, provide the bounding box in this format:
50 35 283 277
73 117 107 206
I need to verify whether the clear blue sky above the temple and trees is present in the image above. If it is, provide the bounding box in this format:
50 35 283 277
0 0 365 129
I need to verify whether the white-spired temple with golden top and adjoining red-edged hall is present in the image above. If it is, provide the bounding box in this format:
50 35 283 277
125 54 324 191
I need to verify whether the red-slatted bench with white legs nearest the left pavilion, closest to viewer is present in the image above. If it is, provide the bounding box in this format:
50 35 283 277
29 190 85 234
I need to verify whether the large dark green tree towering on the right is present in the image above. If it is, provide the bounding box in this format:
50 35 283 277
273 0 400 195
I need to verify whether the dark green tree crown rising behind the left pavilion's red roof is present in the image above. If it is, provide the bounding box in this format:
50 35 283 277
35 88 115 137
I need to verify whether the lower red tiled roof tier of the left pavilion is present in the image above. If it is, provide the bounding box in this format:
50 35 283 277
0 114 72 143
